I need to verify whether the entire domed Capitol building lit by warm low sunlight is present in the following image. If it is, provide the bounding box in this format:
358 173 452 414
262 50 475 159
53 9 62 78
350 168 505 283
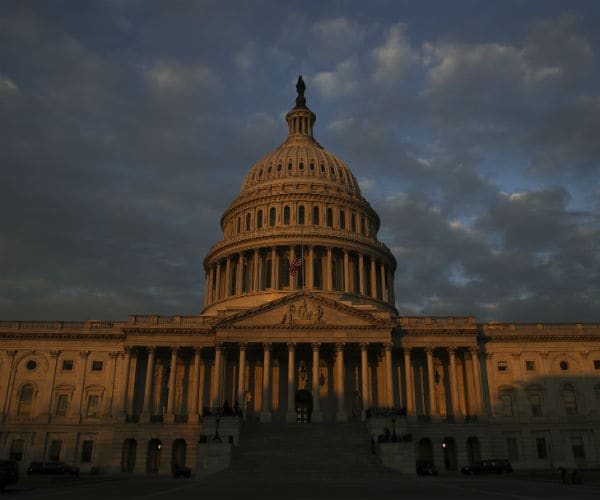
0 78 600 475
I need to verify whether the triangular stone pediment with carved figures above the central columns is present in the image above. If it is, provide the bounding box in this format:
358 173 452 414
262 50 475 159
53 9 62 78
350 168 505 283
216 292 392 329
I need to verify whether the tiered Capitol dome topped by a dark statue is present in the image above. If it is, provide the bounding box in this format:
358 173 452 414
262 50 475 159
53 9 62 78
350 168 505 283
204 77 396 314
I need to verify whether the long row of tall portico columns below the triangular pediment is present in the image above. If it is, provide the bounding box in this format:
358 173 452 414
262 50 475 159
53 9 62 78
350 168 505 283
121 343 483 423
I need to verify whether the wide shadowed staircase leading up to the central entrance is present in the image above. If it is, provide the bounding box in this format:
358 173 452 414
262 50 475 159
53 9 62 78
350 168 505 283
206 422 398 481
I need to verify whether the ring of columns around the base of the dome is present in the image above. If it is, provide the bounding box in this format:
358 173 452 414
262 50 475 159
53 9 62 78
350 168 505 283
204 246 395 306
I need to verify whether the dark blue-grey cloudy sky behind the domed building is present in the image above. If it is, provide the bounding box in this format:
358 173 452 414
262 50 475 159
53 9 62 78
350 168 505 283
0 0 600 322
